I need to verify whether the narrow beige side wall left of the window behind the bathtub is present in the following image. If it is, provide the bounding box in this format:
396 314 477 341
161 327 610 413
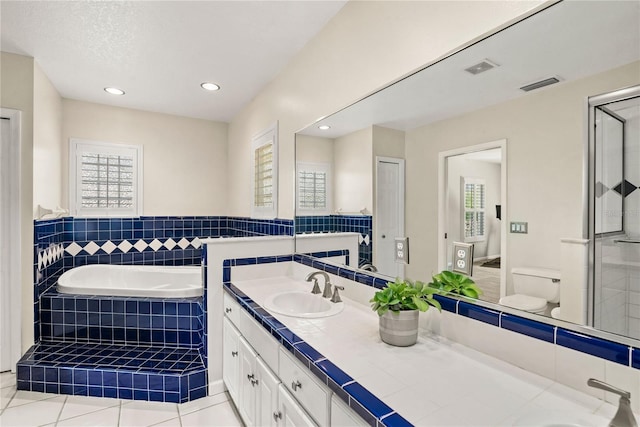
33 63 63 214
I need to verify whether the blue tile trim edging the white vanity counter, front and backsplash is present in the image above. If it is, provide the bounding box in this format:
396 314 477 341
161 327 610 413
223 254 640 427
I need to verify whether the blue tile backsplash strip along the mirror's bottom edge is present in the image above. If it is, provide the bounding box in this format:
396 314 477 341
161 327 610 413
293 254 640 369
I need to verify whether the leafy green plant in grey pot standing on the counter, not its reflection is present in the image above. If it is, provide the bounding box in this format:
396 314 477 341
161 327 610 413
370 279 441 347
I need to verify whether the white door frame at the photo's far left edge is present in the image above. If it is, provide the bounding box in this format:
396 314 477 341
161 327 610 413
0 108 22 372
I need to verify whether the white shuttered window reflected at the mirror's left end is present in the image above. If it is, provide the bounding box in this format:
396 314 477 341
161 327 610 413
297 162 331 215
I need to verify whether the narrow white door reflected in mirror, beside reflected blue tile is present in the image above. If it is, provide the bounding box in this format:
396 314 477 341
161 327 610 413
373 157 404 277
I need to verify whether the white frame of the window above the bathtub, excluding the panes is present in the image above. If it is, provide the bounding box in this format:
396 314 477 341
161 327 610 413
69 138 144 217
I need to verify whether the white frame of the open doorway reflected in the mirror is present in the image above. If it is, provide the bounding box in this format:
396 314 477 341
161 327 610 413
438 139 509 297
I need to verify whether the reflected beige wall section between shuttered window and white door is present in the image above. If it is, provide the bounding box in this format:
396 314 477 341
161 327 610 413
333 126 373 214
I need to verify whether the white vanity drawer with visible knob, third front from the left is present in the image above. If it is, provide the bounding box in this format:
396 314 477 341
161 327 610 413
278 348 331 426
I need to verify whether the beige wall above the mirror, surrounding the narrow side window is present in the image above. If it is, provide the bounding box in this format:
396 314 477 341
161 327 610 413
228 1 542 218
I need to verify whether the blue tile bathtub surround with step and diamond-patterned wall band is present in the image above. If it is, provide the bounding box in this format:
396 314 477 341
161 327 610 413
17 216 293 403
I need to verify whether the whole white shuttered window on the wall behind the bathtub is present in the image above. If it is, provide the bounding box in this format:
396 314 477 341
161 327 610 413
69 139 142 216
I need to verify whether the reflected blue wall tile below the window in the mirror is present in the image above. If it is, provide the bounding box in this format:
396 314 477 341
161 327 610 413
295 215 373 266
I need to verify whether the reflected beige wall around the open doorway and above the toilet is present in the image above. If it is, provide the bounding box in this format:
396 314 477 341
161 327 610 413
405 62 640 291
